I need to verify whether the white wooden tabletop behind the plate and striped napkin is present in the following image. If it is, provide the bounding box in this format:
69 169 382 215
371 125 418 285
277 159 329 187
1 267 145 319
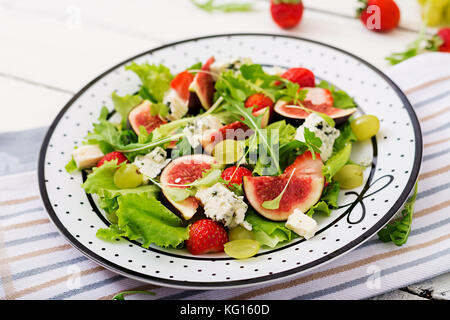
0 0 450 299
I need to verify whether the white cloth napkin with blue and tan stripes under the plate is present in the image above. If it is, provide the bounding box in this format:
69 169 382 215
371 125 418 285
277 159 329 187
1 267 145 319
0 53 450 300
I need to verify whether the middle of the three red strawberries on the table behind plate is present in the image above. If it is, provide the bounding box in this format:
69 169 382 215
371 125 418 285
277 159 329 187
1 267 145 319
357 0 400 32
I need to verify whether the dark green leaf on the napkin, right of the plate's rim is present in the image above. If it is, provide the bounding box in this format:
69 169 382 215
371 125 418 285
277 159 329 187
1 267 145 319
378 181 419 246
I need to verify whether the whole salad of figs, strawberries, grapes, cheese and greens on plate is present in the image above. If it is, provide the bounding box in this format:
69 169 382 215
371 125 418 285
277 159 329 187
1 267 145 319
66 57 380 259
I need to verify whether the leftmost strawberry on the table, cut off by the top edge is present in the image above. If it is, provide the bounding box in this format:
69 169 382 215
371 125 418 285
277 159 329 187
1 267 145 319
270 0 303 29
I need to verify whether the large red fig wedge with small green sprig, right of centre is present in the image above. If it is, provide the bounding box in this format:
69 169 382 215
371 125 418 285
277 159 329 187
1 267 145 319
243 152 324 221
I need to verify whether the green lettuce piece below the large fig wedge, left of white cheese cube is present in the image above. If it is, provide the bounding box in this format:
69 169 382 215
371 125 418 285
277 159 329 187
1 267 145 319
245 209 298 248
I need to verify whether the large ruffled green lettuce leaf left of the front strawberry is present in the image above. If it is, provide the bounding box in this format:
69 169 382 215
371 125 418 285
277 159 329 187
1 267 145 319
116 193 189 248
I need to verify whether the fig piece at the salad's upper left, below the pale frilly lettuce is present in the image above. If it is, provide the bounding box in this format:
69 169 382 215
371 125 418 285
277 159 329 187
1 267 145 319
127 100 166 134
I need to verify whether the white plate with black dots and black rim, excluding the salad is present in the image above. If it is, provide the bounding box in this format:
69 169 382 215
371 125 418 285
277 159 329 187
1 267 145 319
39 34 422 289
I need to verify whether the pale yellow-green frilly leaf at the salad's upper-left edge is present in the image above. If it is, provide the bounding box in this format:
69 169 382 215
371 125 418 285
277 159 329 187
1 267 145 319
125 62 173 103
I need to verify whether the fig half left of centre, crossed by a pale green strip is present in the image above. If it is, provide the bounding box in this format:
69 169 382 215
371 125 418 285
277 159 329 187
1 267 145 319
160 154 215 220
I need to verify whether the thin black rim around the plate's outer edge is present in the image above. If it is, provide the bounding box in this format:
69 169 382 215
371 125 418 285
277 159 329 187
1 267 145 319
38 33 423 289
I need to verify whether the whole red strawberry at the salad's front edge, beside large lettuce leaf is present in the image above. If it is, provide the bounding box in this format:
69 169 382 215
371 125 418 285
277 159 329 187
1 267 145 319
186 219 228 255
